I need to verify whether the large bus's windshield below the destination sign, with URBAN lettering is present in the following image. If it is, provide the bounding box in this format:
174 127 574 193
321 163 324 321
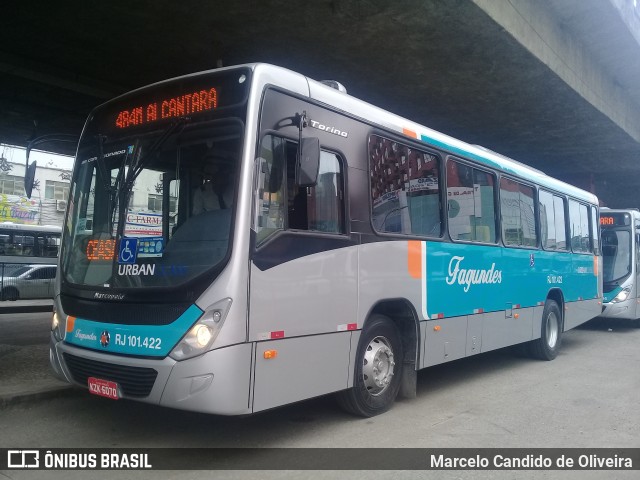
61 119 243 288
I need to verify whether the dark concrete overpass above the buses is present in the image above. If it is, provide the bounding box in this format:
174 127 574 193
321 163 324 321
0 0 640 207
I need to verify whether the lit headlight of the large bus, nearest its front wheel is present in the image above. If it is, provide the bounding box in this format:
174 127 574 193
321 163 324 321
169 298 231 361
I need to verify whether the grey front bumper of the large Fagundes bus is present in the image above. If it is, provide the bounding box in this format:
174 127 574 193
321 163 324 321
49 334 252 415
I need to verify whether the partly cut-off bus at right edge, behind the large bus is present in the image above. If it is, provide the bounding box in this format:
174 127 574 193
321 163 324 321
600 208 640 326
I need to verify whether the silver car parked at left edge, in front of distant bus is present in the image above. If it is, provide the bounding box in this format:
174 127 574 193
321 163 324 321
0 265 57 300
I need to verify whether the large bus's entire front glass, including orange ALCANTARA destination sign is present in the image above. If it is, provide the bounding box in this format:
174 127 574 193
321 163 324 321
60 68 250 289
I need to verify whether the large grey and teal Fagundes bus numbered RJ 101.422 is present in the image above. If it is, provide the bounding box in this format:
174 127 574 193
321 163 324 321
50 64 602 417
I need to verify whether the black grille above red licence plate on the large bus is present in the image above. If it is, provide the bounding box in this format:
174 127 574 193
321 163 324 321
63 353 158 398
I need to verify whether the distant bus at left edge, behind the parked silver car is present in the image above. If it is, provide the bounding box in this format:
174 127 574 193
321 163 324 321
0 222 62 267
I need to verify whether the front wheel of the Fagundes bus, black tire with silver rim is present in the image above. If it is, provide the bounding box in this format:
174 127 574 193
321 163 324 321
337 315 403 417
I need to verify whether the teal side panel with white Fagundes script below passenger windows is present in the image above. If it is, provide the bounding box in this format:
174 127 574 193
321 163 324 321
423 242 598 317
